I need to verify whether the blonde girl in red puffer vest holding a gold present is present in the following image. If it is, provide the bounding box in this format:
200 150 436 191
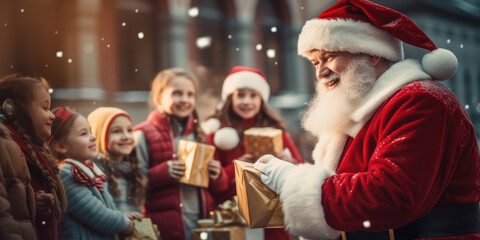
134 68 227 239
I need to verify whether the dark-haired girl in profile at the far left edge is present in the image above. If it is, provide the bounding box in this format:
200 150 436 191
0 76 67 240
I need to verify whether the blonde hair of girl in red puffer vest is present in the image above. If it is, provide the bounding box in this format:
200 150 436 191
149 68 205 142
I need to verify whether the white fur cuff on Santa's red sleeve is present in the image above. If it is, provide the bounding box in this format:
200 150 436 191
280 164 340 239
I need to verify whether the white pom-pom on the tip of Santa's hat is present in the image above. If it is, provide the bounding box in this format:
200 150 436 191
422 48 458 80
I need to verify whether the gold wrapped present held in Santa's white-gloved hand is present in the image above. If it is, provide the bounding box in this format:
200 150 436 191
234 160 284 228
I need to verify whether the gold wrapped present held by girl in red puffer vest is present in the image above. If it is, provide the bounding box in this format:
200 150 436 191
177 140 215 188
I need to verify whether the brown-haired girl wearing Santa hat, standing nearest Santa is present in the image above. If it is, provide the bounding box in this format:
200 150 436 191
204 66 303 240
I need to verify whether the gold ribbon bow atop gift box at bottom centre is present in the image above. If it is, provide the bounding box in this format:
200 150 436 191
197 196 246 228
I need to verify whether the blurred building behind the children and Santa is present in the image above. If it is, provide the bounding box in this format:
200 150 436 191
0 0 480 160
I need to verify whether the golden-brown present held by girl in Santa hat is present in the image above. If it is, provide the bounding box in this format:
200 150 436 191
243 127 283 159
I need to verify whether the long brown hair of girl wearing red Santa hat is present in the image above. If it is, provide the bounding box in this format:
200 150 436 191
209 94 286 136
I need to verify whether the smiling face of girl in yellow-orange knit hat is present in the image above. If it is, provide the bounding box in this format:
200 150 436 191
107 116 135 156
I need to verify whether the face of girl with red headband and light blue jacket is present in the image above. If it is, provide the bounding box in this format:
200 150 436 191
65 115 97 161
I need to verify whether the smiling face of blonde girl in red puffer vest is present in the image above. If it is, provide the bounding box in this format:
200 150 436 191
159 77 195 118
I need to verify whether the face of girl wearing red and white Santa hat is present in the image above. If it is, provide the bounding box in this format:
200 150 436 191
232 88 262 119
